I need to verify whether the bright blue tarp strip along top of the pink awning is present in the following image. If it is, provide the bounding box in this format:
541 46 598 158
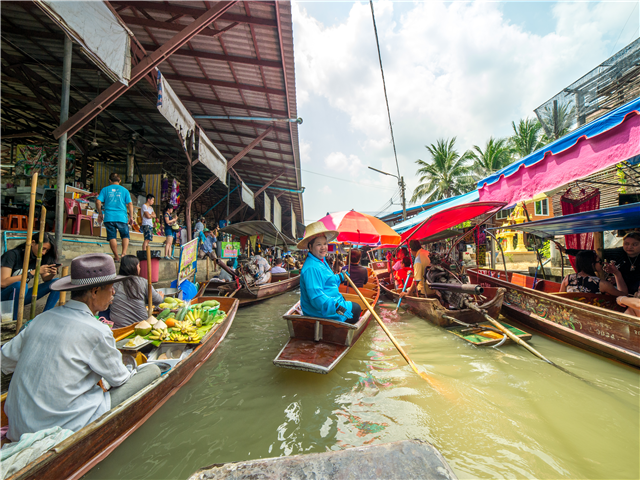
478 98 640 188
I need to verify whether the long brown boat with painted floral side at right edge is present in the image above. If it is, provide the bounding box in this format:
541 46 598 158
467 269 640 367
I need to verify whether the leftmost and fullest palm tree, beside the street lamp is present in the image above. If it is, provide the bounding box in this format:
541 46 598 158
411 137 475 203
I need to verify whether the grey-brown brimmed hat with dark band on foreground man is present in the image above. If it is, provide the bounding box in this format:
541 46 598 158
51 253 127 292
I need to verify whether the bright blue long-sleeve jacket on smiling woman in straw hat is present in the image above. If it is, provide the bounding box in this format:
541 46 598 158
300 254 353 322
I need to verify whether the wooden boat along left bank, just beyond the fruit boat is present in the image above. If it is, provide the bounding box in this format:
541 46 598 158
198 273 300 307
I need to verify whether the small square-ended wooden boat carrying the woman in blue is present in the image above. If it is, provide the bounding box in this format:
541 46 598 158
273 270 380 374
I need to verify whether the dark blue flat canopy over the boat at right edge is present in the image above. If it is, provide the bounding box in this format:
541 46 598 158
496 203 640 237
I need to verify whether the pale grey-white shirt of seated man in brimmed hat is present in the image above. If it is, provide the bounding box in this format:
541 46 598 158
0 300 131 442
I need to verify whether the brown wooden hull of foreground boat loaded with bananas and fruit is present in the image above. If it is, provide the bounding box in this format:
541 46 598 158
0 297 239 480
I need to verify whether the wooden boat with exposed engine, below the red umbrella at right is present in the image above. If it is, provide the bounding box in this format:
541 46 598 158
380 282 505 327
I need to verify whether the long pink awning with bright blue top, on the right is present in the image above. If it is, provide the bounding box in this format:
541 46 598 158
478 98 640 205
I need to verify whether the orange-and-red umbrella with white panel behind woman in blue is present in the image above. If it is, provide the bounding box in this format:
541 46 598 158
318 210 400 245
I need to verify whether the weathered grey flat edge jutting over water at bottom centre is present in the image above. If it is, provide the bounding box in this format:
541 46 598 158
189 440 458 480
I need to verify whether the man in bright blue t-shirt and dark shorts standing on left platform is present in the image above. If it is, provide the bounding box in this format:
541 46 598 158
96 172 133 262
